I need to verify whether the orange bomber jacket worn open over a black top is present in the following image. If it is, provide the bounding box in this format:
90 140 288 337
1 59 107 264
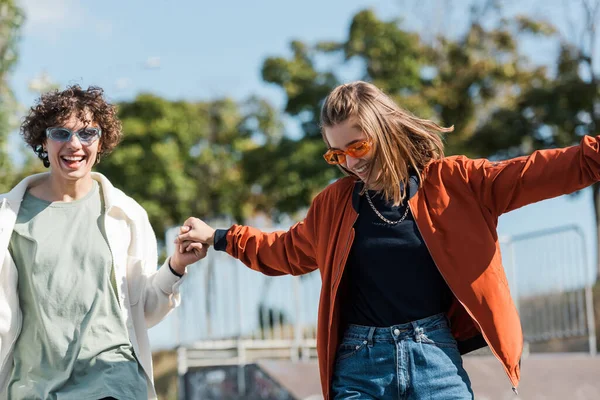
226 136 600 399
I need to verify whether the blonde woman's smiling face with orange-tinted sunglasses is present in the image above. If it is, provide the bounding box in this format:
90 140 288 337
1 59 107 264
325 118 380 185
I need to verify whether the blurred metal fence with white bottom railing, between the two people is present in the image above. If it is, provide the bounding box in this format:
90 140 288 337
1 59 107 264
166 225 321 374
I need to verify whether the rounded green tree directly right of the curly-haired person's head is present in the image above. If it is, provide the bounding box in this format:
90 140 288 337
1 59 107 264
96 94 280 244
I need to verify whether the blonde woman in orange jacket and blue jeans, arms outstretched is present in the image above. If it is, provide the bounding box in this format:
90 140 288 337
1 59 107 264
178 82 600 400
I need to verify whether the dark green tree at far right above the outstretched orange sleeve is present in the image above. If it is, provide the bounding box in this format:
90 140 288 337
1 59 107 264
469 0 600 272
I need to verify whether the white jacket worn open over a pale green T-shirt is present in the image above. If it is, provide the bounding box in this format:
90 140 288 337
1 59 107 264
0 173 183 400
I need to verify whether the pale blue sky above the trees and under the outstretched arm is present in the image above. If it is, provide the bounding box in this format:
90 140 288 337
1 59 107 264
11 0 595 290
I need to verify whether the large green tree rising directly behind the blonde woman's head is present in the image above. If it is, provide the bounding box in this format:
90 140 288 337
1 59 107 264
249 2 544 212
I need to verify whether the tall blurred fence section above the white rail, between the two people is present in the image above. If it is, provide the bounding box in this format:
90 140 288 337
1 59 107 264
173 251 320 345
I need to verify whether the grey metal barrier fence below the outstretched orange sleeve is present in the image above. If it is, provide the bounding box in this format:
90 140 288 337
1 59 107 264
501 225 596 354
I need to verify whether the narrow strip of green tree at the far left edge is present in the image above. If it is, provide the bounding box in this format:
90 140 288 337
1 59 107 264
0 0 23 193
